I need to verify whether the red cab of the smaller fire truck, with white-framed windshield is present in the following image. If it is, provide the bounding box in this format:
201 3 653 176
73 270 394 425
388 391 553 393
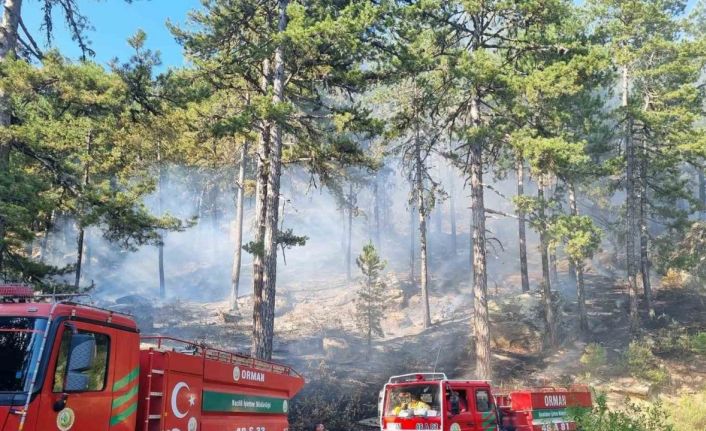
380 373 498 431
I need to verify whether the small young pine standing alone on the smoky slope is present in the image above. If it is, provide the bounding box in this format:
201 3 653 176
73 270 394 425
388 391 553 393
355 243 386 352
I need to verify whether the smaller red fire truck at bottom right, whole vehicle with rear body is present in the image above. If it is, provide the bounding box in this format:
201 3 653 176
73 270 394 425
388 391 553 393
379 373 592 431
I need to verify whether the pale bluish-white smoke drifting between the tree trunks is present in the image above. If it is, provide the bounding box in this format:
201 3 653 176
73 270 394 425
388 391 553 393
40 155 552 302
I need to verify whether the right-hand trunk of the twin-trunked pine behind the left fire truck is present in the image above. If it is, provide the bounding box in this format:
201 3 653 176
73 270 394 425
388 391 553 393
257 0 289 360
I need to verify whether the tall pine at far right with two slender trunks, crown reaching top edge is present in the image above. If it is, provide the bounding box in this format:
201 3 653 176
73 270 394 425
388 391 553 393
588 0 704 334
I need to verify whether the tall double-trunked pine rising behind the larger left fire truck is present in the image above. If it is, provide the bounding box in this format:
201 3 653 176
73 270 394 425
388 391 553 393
172 0 378 359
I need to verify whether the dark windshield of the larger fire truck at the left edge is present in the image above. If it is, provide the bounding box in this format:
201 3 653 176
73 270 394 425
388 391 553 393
0 316 47 392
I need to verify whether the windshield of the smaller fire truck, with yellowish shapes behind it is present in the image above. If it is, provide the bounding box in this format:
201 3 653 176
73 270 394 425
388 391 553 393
385 383 441 417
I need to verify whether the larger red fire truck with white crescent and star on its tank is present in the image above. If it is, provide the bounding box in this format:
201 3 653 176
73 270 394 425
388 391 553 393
0 286 304 431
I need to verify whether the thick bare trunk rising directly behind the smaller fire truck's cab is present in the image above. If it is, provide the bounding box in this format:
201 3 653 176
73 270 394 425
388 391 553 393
470 96 492 380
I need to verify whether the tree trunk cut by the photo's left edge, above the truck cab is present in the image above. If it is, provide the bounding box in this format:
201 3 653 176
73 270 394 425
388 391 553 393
0 0 22 274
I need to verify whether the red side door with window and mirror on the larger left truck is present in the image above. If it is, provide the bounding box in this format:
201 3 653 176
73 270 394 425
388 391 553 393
37 321 116 431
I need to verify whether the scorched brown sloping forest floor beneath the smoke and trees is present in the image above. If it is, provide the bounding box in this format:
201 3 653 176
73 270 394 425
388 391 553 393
131 256 706 428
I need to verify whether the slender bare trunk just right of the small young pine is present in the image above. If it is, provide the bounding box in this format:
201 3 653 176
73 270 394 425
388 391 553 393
414 130 431 329
